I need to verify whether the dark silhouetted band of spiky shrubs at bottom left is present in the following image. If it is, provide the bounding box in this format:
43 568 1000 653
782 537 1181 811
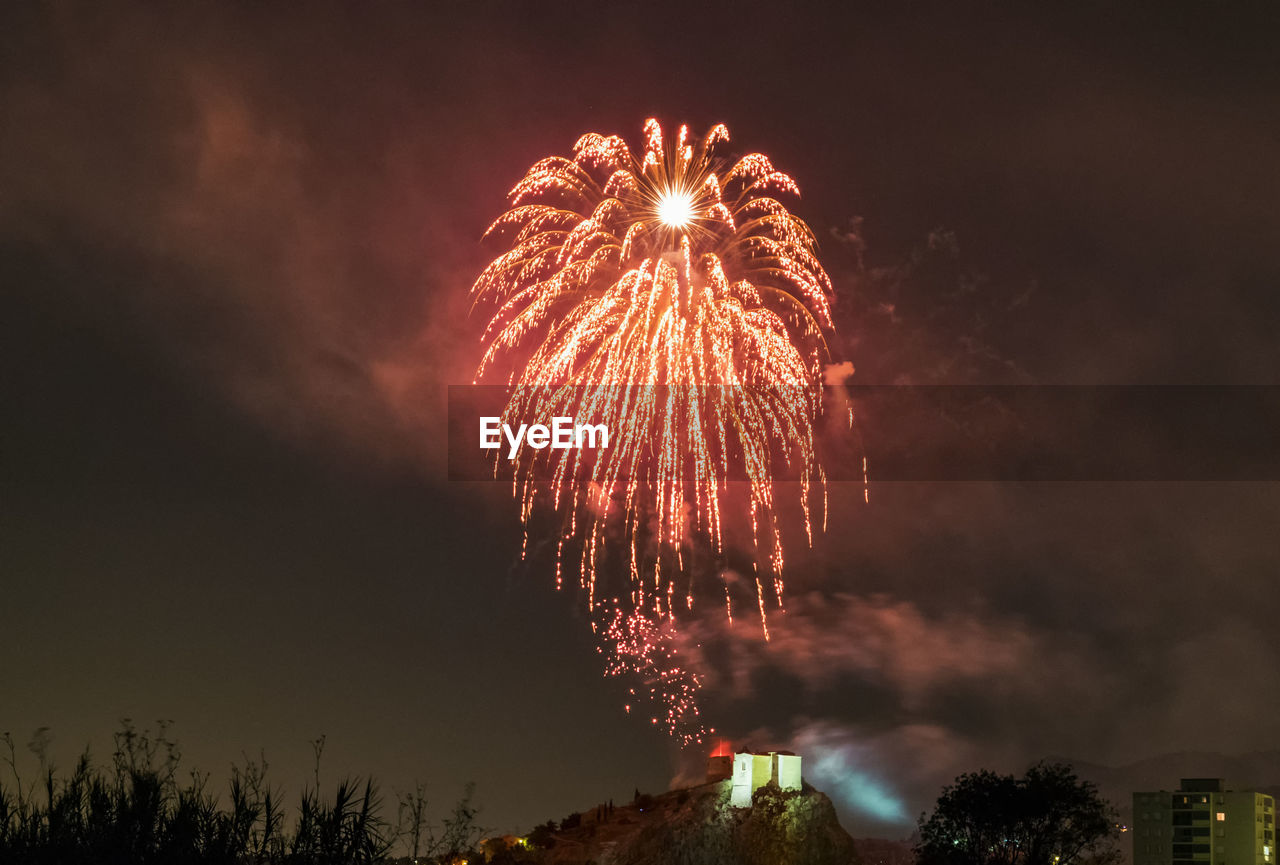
0 719 479 865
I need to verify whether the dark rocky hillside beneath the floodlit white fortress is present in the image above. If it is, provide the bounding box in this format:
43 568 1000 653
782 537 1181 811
517 781 858 865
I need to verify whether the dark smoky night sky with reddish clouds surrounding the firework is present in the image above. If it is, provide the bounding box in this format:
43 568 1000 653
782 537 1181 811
0 3 1280 837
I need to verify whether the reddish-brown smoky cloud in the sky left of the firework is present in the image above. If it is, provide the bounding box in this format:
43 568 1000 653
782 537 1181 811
0 6 483 478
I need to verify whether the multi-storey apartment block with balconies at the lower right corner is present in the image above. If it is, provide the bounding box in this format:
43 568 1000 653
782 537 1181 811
1133 778 1276 865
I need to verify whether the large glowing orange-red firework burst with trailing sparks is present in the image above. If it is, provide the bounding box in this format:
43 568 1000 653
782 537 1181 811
472 120 831 740
